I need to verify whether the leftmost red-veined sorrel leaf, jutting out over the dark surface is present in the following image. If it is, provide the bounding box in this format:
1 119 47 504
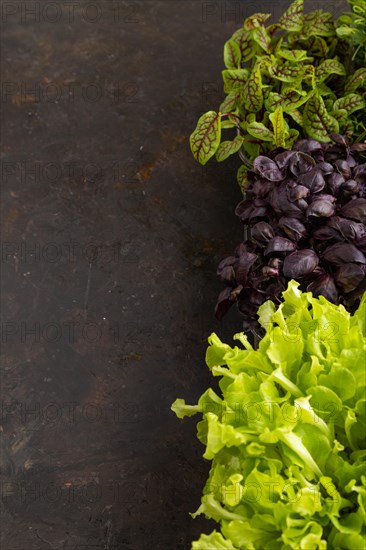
190 111 221 164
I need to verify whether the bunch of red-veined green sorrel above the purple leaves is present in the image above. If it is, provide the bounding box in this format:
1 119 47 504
191 0 366 166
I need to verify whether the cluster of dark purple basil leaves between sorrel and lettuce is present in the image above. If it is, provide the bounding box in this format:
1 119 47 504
215 134 366 331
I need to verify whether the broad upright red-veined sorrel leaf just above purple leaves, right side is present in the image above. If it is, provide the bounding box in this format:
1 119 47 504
304 93 339 142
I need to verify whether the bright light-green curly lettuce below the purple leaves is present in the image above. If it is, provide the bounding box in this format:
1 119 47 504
172 281 366 550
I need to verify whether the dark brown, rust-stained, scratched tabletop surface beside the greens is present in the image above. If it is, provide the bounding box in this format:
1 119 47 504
1 0 346 550
